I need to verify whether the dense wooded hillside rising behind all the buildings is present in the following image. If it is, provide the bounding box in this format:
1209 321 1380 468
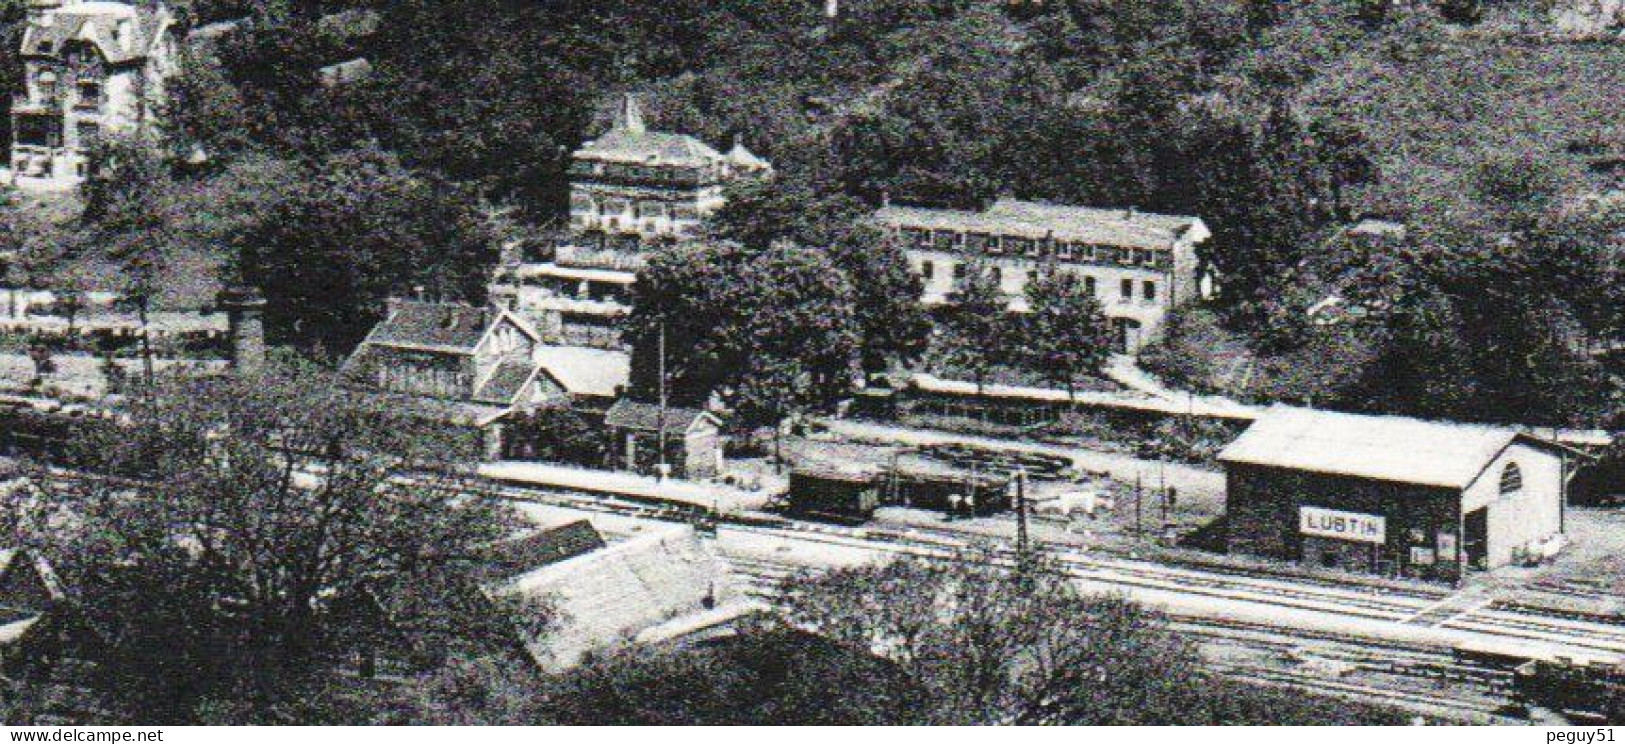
5 0 1625 426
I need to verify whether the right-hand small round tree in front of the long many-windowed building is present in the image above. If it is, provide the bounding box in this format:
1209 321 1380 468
1017 263 1112 401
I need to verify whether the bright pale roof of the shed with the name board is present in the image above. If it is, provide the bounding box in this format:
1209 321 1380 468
1219 406 1539 491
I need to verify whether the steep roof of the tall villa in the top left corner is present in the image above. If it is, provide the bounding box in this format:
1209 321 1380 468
23 2 172 65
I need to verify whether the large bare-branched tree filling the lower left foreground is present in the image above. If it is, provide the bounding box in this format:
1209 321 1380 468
10 366 514 721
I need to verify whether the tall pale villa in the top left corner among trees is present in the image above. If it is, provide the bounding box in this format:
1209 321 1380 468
10 0 177 190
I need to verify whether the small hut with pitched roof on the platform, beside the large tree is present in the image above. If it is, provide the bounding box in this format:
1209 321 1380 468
605 398 723 481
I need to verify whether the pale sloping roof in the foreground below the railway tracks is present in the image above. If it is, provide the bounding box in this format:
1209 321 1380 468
496 526 735 671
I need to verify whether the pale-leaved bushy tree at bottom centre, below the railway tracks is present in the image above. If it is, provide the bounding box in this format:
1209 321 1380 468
788 552 1199 725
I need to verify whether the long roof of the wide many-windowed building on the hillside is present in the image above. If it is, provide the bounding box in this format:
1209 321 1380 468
874 200 1201 249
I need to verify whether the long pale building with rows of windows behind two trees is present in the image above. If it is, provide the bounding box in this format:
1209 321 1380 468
874 198 1211 353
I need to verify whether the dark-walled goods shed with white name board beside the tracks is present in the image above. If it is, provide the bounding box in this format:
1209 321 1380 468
1219 406 1573 583
